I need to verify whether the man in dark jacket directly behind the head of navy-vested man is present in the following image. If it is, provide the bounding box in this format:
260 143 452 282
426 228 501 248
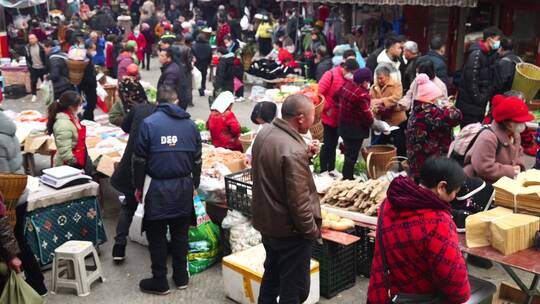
157 48 191 110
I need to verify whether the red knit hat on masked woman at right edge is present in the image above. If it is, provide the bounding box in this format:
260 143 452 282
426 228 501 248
491 95 534 122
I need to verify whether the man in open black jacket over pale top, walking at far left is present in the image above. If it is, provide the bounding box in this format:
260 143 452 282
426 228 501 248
24 34 47 102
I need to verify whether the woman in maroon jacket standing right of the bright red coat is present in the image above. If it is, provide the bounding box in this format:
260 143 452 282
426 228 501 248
334 68 373 180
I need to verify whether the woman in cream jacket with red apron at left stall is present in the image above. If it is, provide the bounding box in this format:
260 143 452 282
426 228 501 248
47 91 92 174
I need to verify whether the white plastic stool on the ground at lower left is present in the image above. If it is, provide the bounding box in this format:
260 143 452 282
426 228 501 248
52 241 105 297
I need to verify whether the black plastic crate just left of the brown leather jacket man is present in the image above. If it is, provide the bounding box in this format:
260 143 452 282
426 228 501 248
225 169 253 216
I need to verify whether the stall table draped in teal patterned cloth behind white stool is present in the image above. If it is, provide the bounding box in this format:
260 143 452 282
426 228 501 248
24 177 107 265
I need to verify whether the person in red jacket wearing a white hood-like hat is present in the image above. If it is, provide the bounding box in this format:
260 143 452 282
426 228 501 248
206 91 242 151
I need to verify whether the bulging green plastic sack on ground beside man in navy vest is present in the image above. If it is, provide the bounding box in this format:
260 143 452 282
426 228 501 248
188 196 220 274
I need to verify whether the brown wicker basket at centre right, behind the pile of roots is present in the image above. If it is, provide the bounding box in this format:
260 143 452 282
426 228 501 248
362 145 397 179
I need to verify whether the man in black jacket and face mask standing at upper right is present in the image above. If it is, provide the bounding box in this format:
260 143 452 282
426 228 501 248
456 27 502 128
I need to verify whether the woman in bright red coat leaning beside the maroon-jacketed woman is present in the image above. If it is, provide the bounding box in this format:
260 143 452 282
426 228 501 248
319 59 359 172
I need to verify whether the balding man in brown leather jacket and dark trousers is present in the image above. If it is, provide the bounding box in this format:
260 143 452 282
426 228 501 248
252 95 321 304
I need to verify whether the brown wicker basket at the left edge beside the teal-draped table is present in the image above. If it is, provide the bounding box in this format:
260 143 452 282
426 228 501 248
0 173 28 227
